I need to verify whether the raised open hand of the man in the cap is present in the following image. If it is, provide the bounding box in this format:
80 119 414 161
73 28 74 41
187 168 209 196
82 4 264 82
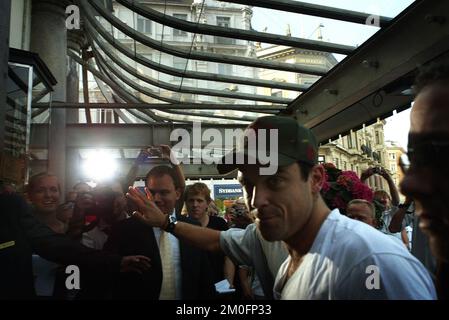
126 187 167 228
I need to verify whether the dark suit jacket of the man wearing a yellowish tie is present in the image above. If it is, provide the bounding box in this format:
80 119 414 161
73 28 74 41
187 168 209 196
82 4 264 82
104 217 215 300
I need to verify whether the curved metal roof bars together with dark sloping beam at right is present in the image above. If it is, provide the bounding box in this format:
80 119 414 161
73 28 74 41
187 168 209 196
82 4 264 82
28 0 448 134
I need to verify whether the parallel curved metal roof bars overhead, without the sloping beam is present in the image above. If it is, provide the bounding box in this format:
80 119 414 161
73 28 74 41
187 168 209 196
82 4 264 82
59 0 382 124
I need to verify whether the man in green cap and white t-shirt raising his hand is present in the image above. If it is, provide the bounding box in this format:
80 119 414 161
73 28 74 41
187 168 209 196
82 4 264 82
125 116 435 299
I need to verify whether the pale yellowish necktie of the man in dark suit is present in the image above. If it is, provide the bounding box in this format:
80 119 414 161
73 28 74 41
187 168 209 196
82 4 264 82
159 230 176 300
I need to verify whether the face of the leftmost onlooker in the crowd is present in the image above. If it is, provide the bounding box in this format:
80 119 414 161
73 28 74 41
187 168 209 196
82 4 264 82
29 176 59 213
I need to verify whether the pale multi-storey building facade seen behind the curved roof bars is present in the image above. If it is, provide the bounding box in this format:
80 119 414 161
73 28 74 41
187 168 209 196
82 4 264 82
113 0 256 103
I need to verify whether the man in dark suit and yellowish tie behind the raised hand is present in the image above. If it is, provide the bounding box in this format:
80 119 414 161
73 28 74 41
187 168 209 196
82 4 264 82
105 166 215 300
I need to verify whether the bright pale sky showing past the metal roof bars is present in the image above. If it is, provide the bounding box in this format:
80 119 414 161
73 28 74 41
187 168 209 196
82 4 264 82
252 0 413 149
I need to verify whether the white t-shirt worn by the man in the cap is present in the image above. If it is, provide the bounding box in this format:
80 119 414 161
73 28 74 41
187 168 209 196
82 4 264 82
274 209 436 300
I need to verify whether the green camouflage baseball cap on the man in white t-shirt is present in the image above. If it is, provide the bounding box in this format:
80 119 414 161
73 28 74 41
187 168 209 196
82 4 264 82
217 116 318 174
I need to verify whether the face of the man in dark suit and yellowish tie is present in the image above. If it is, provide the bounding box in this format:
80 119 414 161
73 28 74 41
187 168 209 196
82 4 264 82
147 174 180 214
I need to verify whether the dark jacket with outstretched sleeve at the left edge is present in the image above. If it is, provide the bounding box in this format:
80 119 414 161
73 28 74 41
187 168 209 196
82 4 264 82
0 195 121 299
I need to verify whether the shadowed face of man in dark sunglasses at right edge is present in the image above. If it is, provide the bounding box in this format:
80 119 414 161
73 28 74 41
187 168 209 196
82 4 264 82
401 85 449 261
